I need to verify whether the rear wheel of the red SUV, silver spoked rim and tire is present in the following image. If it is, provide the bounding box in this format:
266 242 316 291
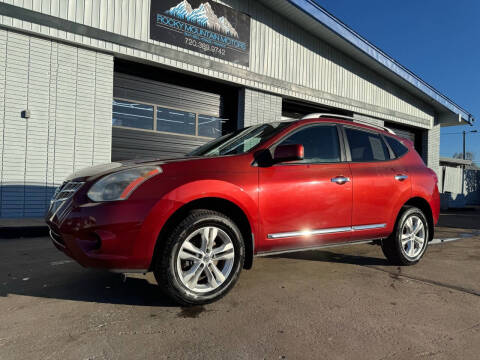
382 206 431 266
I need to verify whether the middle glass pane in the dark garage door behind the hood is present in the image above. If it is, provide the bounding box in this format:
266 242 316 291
157 107 196 135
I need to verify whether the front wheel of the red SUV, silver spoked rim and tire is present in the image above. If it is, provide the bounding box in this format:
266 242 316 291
154 210 245 306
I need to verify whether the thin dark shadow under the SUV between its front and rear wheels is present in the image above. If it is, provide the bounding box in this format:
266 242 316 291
270 250 392 266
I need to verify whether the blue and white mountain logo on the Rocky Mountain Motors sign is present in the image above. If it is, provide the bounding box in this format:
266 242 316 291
165 0 238 38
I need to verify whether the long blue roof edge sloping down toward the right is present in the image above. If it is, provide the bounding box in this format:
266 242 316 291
288 0 475 125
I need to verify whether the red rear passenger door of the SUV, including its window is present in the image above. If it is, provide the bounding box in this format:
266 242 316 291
343 126 411 240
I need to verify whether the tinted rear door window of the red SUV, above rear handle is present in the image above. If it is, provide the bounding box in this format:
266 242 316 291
345 128 390 162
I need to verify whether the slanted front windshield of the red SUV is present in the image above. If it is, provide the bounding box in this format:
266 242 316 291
188 122 291 156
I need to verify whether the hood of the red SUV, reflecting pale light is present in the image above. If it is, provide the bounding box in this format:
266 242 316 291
65 157 204 181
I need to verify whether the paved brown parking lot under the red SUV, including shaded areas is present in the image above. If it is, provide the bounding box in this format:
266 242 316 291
0 212 480 360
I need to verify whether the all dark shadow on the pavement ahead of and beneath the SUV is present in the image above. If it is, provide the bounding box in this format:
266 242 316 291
0 239 394 307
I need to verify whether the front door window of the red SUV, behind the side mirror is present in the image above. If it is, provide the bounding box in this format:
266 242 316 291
279 125 340 163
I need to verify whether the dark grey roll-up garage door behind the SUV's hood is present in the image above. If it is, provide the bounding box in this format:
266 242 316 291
112 73 223 161
